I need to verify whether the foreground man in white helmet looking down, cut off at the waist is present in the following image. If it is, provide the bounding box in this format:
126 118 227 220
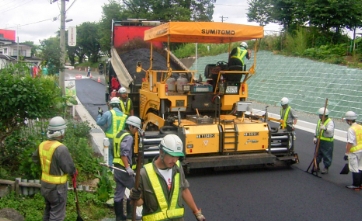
130 134 205 221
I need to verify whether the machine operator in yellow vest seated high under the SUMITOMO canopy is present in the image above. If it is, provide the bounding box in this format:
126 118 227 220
228 42 251 71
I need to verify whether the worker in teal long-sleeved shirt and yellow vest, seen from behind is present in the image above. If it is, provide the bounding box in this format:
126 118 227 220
97 97 127 165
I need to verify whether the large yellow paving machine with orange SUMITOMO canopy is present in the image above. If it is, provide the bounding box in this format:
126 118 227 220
135 22 298 170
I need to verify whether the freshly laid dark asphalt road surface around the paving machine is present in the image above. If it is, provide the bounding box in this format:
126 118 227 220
68 70 362 221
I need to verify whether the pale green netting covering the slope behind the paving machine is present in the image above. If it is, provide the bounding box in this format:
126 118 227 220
190 51 362 121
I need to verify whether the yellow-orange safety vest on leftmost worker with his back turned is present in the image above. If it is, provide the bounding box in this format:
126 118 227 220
39 141 67 184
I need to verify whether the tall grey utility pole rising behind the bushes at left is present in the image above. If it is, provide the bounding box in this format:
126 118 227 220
59 0 66 95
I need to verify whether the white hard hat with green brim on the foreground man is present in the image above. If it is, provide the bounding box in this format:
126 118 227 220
160 134 185 157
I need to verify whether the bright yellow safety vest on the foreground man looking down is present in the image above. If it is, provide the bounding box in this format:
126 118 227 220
142 161 185 221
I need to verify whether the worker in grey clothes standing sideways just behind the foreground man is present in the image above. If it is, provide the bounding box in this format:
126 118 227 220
113 116 141 221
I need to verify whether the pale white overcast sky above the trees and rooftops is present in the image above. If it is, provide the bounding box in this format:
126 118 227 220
0 0 281 44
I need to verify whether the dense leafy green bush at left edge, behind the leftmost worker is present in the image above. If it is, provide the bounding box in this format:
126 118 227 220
0 64 61 143
